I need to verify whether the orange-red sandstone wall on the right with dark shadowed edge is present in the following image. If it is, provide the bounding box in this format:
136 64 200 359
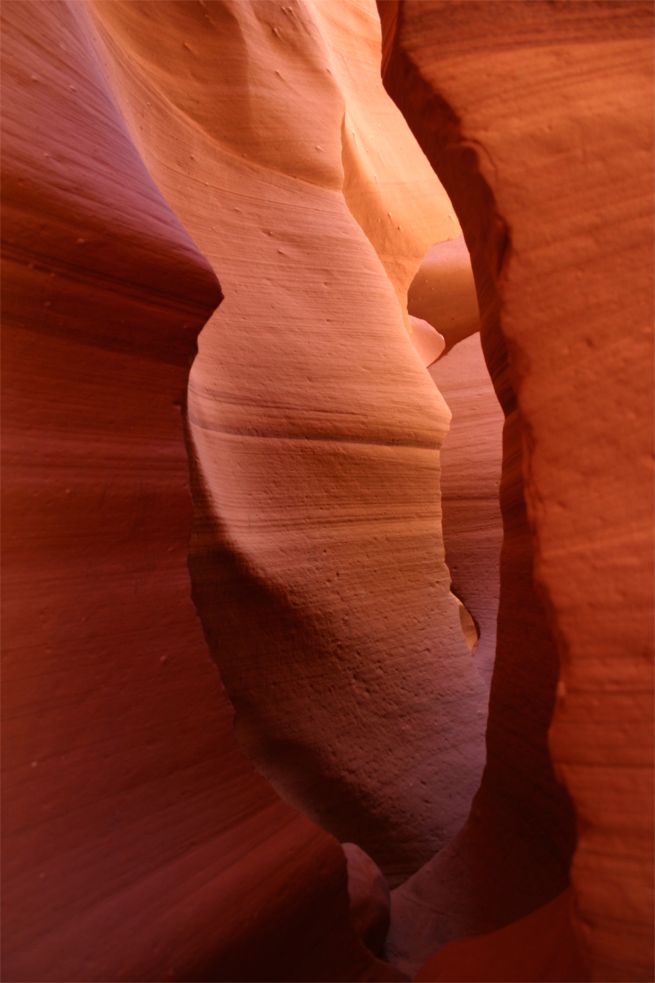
382 2 653 981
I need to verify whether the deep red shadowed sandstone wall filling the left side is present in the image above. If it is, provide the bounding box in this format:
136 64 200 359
2 2 398 983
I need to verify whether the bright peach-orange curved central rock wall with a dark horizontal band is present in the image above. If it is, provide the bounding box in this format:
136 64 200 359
88 2 492 880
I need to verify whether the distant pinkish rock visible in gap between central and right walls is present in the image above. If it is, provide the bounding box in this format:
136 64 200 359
408 236 503 684
